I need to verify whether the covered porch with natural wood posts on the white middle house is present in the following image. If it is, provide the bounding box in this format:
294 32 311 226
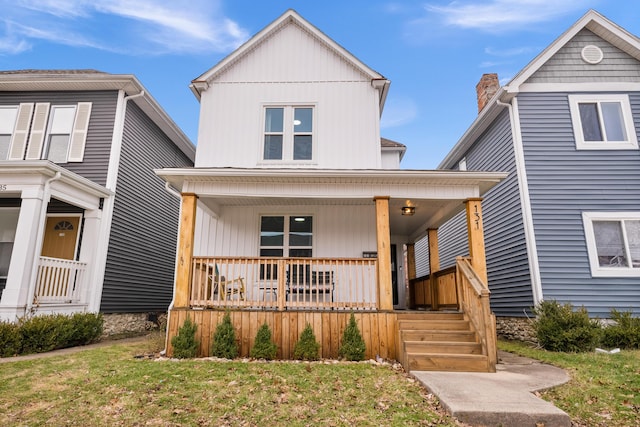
157 169 504 370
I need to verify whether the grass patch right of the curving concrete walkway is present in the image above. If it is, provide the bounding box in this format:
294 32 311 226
498 341 640 427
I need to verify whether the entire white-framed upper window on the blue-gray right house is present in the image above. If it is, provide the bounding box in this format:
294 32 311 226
569 95 638 150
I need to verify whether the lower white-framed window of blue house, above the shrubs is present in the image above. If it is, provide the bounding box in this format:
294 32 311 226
582 212 640 277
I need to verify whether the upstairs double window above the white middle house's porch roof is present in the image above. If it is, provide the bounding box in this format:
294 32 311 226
263 106 313 161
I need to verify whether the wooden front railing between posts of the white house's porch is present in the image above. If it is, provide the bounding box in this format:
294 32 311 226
189 257 378 311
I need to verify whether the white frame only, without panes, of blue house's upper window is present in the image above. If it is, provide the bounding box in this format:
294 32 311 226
569 94 638 150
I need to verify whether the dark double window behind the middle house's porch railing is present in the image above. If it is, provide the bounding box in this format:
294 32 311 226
260 215 313 279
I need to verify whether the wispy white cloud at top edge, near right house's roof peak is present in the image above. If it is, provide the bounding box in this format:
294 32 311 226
425 0 593 32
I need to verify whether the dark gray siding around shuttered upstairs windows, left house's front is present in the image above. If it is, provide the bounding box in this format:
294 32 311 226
0 91 118 185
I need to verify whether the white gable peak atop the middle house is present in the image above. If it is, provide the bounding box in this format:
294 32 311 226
191 9 389 98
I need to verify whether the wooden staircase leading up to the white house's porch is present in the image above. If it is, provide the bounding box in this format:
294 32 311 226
398 311 493 372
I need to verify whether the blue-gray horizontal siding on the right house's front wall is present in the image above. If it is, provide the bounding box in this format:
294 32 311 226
518 93 640 317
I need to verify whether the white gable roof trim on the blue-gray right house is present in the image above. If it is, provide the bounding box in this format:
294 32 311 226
504 10 640 93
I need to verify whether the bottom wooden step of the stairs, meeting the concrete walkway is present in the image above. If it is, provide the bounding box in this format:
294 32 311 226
406 353 489 372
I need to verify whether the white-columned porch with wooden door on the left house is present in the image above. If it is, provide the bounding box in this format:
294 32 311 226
0 160 112 321
